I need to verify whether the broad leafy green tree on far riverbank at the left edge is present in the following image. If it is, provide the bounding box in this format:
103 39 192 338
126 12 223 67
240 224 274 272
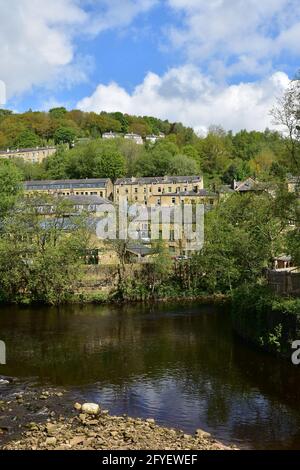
0 196 90 304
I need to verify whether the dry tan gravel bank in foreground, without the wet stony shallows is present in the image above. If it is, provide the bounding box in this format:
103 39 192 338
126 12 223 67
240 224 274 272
2 405 234 450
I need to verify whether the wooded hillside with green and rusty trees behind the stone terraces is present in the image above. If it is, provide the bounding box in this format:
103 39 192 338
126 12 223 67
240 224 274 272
0 108 293 184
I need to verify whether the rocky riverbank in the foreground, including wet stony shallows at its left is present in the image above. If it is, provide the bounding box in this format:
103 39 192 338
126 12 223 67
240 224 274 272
0 382 234 450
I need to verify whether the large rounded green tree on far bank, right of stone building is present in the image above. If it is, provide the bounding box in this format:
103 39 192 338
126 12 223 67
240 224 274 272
191 193 286 292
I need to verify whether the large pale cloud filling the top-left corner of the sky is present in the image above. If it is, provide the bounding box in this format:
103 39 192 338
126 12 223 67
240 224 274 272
0 0 156 98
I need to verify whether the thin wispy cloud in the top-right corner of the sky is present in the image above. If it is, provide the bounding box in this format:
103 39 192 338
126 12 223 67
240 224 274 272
168 0 300 76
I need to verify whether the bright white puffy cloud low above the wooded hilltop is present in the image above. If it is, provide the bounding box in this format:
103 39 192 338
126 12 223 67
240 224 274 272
77 65 289 131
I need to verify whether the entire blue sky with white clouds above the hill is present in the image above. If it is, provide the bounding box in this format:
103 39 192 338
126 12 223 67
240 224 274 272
0 0 300 131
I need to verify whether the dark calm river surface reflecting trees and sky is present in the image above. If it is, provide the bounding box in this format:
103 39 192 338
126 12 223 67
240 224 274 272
0 303 300 449
